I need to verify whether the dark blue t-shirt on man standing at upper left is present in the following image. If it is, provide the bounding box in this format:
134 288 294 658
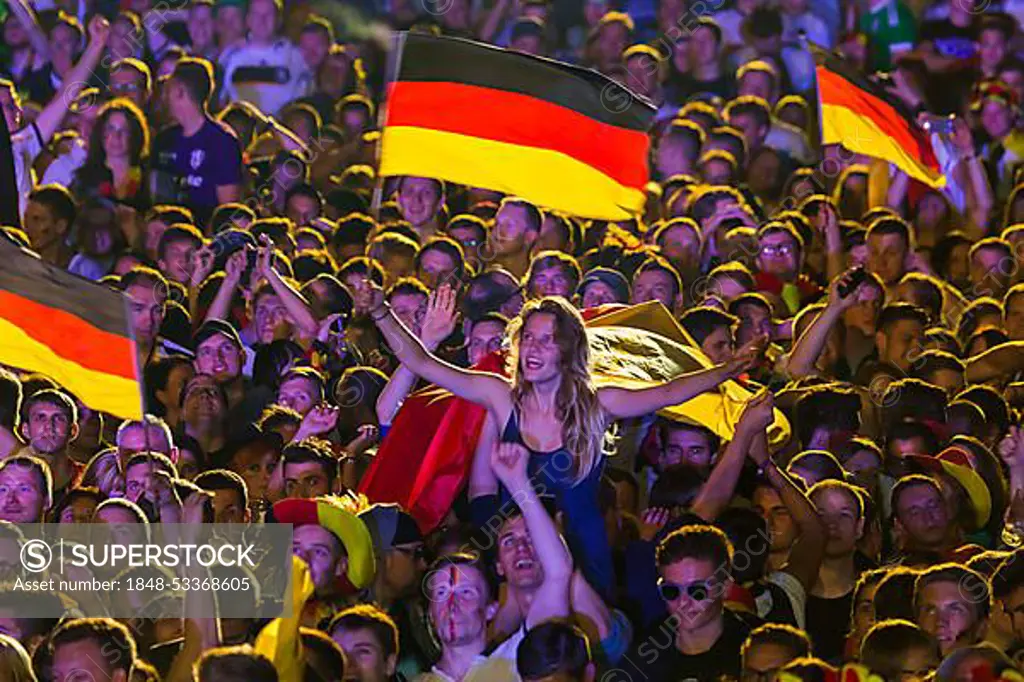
153 119 242 222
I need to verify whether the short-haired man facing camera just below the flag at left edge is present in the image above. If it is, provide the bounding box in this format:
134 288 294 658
18 388 85 503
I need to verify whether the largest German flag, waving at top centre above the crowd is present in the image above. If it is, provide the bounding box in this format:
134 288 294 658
380 33 654 220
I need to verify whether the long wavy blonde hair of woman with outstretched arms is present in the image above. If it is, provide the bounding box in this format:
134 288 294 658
509 297 607 483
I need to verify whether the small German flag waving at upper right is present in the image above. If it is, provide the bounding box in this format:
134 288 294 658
811 45 946 187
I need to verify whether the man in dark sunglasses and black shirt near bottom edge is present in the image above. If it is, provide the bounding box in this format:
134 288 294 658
621 524 752 682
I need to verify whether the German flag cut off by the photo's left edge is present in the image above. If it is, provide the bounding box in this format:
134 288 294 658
0 240 142 419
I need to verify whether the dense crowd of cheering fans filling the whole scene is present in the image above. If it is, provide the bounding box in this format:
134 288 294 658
0 0 1024 682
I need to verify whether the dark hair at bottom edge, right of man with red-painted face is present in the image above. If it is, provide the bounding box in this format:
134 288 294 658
516 621 593 682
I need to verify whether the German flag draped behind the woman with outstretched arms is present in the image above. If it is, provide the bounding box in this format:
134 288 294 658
359 301 790 531
